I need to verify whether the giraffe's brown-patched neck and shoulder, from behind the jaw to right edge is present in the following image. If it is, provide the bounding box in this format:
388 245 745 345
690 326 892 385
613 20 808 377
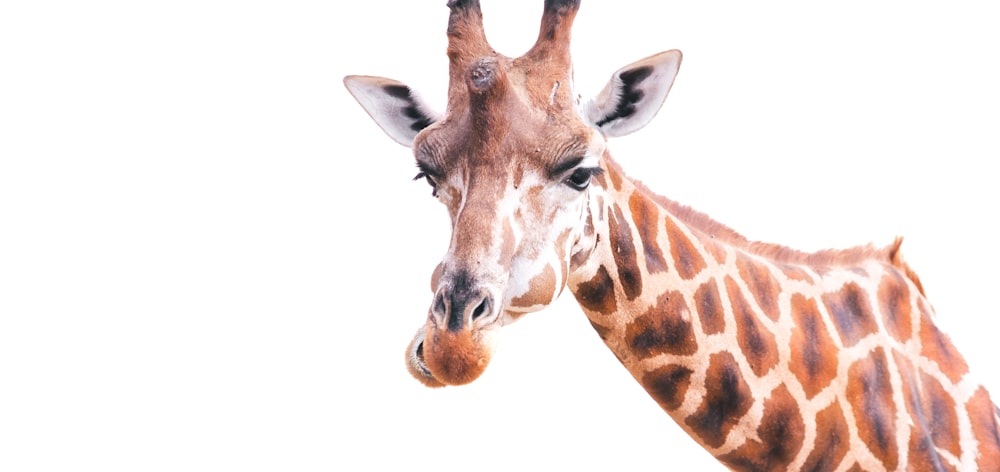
569 156 1000 470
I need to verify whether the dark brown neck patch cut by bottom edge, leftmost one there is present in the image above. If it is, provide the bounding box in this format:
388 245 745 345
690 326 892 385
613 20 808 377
719 385 805 471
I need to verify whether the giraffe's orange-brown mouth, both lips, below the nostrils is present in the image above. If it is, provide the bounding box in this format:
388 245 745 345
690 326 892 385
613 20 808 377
406 326 497 388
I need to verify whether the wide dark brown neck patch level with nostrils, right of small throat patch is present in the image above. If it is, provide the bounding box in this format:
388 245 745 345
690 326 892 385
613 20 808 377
625 292 698 358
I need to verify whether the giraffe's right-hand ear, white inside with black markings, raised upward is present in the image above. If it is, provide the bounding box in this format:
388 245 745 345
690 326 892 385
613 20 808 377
584 49 681 137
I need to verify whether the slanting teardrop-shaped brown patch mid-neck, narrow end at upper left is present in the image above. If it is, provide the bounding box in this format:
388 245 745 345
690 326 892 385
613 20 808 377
726 276 778 377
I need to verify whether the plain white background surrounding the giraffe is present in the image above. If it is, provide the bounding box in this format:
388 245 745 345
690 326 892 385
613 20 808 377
0 0 1000 471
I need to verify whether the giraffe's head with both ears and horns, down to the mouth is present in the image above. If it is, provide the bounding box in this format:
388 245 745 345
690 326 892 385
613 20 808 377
344 0 681 386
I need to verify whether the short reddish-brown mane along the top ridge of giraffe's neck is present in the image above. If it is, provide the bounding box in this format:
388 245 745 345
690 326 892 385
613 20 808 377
607 156 924 294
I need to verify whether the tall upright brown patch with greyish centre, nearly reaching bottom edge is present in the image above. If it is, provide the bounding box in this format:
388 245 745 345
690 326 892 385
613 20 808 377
846 348 899 470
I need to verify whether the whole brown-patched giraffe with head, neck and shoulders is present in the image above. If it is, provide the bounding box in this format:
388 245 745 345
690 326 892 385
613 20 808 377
345 0 1000 471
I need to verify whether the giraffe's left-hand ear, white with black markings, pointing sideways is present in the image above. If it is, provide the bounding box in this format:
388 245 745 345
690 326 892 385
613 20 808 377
344 75 440 147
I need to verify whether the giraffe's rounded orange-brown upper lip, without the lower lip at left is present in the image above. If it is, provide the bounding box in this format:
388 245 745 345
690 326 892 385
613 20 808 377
423 326 496 385
